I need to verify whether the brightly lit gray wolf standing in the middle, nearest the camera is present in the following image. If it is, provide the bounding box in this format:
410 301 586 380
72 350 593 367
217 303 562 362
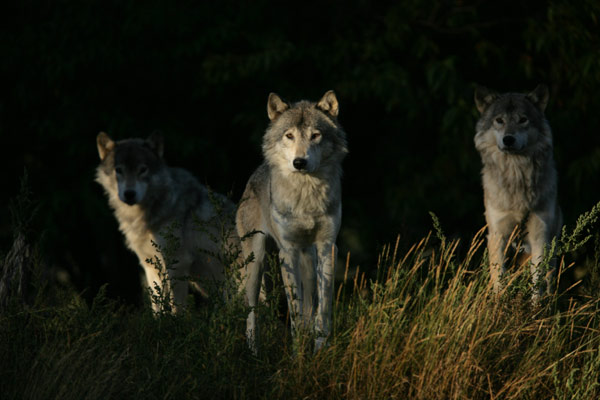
236 91 348 352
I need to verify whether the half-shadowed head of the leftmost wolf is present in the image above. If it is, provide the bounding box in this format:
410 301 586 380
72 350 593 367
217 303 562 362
96 132 164 205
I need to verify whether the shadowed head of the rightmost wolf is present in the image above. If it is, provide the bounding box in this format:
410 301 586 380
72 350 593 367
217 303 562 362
475 85 549 154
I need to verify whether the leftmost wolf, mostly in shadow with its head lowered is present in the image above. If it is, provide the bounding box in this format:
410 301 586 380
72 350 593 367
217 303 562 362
96 132 237 313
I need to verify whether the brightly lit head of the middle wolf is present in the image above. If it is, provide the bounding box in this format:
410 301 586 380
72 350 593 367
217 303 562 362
263 90 348 174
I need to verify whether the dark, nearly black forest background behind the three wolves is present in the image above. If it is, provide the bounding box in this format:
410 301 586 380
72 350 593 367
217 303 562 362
0 0 600 303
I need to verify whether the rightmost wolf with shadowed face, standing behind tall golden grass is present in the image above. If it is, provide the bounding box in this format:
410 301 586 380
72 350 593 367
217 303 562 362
474 85 562 303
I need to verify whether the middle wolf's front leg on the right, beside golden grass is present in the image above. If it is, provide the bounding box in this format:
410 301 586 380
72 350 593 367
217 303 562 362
315 242 337 351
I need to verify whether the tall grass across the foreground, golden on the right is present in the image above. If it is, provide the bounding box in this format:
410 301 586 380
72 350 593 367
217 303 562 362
0 206 600 399
